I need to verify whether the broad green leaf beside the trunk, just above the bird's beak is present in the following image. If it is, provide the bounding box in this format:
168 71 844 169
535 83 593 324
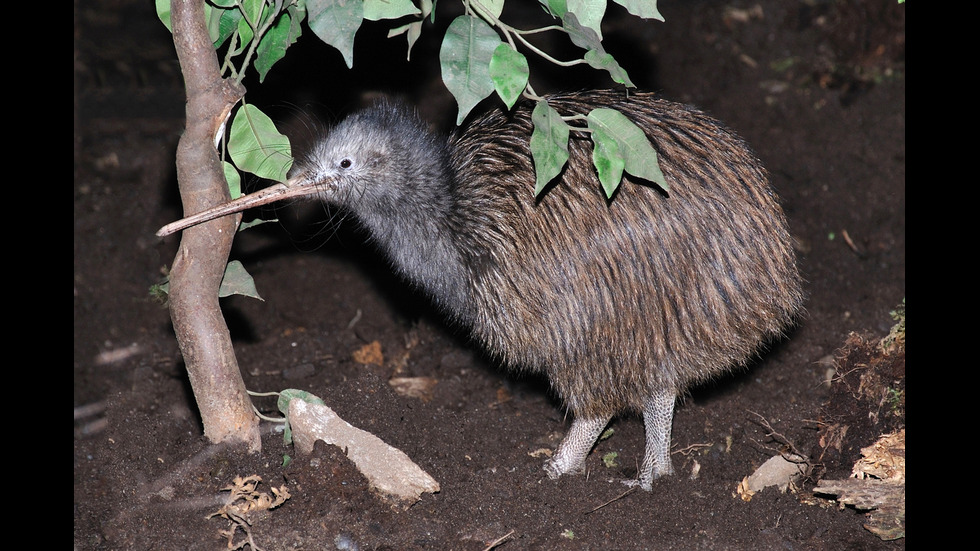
228 104 293 182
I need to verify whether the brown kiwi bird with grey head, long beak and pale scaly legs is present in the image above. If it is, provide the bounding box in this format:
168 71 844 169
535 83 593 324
160 91 804 489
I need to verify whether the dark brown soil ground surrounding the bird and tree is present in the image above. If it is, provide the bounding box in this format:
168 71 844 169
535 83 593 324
73 0 905 550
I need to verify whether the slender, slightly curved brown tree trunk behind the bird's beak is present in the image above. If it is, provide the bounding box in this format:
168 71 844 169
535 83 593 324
169 0 262 451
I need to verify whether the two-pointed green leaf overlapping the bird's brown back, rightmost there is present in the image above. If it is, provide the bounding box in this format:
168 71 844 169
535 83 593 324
587 108 670 197
